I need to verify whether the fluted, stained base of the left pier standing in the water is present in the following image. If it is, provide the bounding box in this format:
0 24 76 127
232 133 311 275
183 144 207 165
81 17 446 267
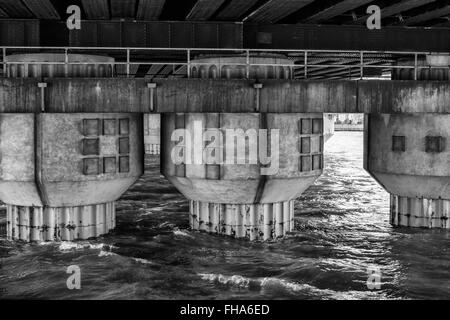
7 202 116 242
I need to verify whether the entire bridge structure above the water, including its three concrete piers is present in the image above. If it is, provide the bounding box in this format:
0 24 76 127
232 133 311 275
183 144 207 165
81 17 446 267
0 0 450 241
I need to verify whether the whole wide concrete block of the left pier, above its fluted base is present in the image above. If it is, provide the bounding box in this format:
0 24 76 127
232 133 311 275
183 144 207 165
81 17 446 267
0 114 143 207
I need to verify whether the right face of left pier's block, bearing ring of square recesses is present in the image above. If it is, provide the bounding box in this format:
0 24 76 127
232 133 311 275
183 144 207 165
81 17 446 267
38 114 144 207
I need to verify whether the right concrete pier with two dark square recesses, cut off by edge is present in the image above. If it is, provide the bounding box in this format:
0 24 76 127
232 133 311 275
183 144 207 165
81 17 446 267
365 56 450 229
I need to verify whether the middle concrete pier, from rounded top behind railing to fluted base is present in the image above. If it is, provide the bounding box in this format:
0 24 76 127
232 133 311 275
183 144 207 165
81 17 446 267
161 55 324 240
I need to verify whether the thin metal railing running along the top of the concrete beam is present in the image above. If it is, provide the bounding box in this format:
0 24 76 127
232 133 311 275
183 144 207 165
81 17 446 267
1 46 450 79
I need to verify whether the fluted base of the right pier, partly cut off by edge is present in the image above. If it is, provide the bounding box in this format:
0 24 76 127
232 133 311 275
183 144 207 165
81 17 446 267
391 195 450 229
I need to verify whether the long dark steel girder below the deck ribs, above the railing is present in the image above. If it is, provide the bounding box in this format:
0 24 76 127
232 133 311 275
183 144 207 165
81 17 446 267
0 19 450 52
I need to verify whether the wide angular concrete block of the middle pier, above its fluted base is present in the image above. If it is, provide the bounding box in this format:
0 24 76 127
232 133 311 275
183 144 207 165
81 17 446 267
161 113 323 204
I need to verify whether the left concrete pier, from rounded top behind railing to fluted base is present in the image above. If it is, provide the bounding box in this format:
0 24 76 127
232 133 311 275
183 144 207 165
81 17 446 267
0 54 143 241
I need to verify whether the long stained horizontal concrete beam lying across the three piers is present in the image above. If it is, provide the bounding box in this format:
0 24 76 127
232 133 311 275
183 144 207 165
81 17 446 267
0 78 450 113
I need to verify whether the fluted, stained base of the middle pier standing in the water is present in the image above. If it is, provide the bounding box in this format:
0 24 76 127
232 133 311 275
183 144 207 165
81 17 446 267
189 201 294 241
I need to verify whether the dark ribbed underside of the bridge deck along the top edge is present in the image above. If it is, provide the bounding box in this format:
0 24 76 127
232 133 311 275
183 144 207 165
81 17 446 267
0 0 450 27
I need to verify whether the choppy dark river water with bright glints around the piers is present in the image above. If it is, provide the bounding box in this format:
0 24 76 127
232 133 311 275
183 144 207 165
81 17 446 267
0 132 450 299
